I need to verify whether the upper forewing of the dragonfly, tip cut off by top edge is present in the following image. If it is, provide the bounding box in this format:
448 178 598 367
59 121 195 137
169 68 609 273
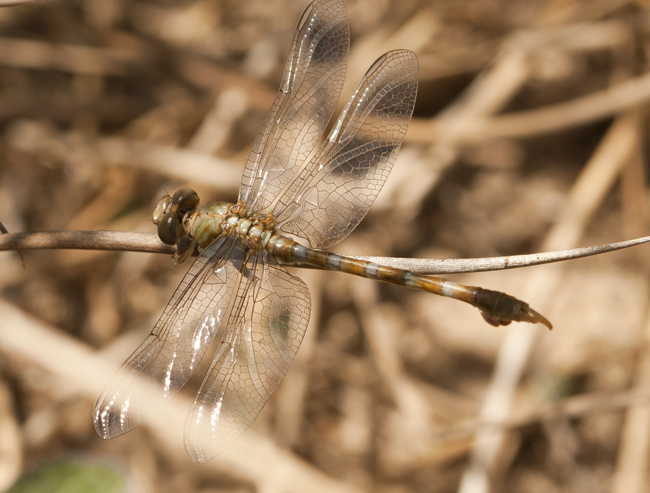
239 0 350 212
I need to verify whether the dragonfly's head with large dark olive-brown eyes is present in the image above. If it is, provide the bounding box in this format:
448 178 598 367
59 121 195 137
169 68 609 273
153 188 199 245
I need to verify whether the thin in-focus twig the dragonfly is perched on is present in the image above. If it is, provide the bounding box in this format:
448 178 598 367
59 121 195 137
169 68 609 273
0 231 650 275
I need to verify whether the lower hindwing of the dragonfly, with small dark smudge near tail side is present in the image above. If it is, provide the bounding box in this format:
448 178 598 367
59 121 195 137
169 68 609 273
185 252 310 462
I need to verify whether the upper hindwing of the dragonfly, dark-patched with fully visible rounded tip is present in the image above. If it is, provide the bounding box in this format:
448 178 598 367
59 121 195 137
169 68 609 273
273 50 418 248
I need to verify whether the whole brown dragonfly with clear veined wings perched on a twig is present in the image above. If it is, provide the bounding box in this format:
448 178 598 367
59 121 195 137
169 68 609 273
93 0 551 463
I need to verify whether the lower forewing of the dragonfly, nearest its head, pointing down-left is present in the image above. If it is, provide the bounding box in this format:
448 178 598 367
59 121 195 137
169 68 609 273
93 237 244 438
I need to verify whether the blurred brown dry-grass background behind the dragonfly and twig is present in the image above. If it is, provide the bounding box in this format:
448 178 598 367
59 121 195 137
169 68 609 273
0 0 650 493
